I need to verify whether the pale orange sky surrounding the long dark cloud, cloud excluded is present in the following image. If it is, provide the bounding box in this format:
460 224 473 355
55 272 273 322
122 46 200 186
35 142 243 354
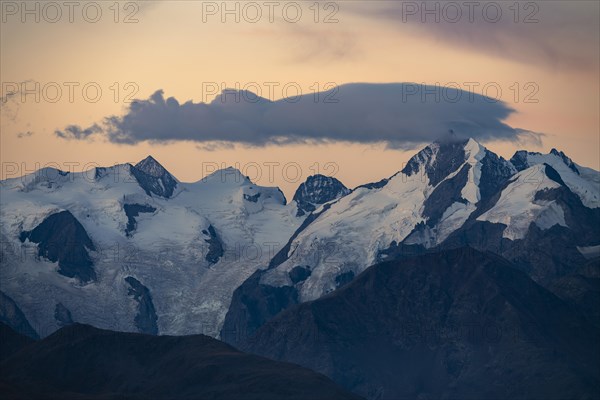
0 1 600 197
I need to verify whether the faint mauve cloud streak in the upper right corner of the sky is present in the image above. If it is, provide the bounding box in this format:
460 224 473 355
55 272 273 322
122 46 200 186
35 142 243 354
345 1 600 71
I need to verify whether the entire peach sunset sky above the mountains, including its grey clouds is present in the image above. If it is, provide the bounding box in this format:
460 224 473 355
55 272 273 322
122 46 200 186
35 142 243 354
0 1 600 199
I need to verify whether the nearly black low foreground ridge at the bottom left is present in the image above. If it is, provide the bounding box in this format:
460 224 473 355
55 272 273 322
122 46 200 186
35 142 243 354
0 324 360 400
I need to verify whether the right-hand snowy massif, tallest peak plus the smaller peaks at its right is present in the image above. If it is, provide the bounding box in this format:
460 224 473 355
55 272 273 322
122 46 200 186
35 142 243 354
221 138 600 343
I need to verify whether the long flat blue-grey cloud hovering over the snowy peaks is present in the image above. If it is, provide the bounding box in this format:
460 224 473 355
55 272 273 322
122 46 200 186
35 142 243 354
56 83 539 148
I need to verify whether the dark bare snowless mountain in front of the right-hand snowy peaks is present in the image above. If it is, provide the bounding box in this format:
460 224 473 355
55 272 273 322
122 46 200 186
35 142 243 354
242 248 600 400
